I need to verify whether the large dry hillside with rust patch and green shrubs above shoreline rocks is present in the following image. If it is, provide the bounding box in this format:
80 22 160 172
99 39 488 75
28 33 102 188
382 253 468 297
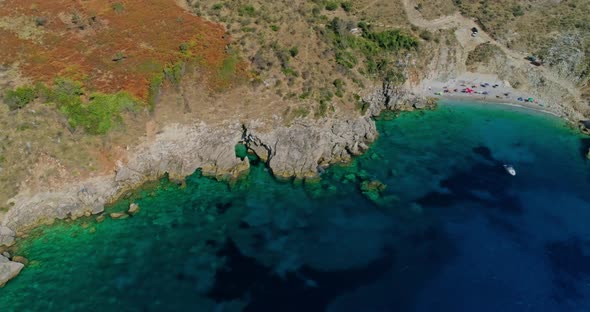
0 0 432 210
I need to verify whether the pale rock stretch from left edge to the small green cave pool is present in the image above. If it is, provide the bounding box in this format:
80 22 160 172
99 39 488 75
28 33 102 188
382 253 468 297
0 123 250 241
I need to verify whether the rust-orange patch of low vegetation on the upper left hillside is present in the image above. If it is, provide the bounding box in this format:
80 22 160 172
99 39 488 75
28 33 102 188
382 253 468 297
0 0 236 99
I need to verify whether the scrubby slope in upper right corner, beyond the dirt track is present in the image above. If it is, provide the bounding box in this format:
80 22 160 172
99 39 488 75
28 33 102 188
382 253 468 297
455 0 590 99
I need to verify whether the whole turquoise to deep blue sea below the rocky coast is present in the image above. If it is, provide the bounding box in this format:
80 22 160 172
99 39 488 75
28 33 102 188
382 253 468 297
0 103 590 311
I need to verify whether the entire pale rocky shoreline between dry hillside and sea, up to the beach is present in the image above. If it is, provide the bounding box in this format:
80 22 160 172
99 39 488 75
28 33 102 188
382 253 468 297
0 84 432 285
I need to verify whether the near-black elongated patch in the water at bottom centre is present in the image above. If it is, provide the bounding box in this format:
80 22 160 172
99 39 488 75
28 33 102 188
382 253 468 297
208 240 393 312
